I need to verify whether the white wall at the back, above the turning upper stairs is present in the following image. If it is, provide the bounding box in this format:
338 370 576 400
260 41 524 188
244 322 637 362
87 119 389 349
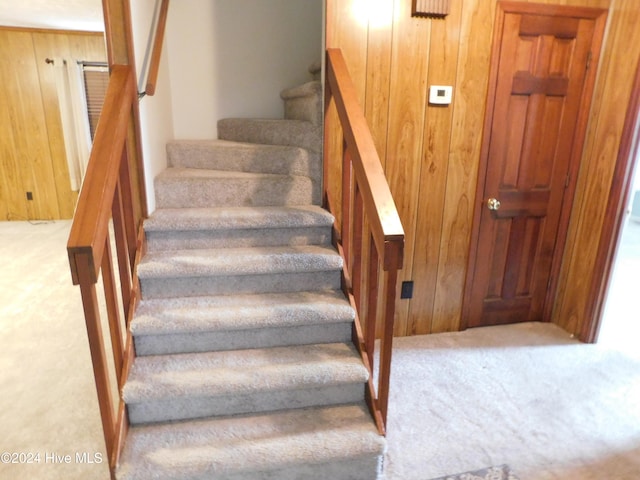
168 0 323 138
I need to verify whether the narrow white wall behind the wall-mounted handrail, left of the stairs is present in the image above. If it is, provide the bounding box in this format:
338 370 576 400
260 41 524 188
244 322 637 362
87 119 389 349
130 0 177 213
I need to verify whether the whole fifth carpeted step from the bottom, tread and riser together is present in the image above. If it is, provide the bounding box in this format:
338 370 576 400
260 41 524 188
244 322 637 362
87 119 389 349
144 205 334 252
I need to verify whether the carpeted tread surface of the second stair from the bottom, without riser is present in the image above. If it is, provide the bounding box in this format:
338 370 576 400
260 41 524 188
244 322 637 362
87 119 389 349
123 343 368 404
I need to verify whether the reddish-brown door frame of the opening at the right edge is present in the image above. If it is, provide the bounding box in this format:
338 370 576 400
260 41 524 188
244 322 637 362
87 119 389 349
579 60 640 343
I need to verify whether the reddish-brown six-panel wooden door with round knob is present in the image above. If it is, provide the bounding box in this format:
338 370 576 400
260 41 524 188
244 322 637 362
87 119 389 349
463 2 605 327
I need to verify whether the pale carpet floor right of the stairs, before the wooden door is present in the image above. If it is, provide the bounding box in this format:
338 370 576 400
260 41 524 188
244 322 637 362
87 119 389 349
386 323 640 480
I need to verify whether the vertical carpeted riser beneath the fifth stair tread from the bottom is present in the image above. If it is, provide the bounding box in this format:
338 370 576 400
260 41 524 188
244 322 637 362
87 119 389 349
146 227 331 252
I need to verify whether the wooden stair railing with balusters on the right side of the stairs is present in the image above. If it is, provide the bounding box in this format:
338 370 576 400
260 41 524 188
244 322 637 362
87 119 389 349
323 49 404 434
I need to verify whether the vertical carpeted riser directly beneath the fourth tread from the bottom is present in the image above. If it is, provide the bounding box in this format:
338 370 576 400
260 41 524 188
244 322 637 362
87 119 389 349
140 270 340 298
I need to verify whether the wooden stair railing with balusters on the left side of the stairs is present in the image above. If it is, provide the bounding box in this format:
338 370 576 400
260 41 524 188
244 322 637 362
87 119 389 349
67 65 143 477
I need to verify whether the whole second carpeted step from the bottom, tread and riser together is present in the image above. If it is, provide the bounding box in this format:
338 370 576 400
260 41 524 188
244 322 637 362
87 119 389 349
123 343 368 424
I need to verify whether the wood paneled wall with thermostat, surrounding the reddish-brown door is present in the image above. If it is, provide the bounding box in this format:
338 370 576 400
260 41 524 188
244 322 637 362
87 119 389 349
326 0 640 335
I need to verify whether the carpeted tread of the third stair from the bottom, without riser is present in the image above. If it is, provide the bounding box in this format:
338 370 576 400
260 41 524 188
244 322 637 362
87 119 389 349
131 291 354 336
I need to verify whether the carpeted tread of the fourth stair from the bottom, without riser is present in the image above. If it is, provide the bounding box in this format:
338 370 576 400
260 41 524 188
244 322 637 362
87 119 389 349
138 245 342 280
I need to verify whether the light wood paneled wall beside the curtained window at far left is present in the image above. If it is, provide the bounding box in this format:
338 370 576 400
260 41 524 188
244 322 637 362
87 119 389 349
0 27 106 220
